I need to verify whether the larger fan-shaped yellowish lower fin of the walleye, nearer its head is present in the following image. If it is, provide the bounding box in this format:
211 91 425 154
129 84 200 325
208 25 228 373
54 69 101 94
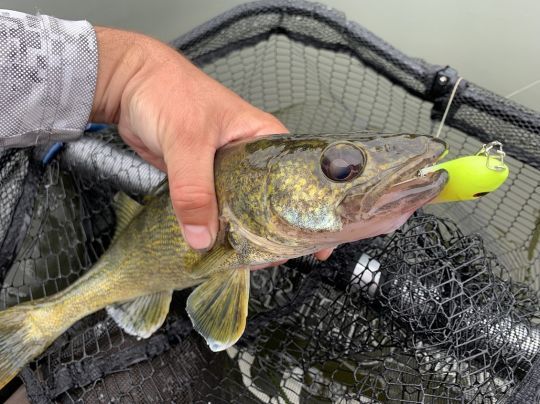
186 267 249 352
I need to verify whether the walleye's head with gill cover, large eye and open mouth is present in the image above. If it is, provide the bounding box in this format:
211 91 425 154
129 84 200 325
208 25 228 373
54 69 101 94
215 132 448 250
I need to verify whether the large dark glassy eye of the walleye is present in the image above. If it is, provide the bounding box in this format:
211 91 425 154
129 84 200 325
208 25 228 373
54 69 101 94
321 143 366 182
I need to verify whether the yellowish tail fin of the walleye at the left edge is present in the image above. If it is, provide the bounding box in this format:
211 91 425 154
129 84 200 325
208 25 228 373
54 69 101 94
0 304 53 390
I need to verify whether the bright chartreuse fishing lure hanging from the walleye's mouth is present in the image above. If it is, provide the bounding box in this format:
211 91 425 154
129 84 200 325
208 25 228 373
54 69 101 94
419 141 509 203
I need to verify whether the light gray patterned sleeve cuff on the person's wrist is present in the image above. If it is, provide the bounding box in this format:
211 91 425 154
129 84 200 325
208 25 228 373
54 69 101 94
0 10 98 147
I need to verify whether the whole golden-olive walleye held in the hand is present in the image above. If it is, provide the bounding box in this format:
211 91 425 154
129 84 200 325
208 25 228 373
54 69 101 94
0 133 448 388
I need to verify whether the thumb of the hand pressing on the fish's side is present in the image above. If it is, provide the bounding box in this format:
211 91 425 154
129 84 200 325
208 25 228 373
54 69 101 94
163 138 218 251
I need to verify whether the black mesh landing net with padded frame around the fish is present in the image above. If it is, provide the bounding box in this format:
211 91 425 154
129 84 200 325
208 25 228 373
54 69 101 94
0 1 540 403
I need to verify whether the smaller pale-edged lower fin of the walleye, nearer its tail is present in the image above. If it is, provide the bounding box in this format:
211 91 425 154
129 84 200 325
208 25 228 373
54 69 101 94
107 290 172 338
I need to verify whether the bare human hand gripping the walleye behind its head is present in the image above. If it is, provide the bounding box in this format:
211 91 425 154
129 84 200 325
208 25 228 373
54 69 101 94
91 27 331 259
